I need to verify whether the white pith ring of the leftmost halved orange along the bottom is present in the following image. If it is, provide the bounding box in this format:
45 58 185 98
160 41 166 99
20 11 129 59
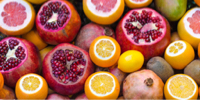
19 74 43 94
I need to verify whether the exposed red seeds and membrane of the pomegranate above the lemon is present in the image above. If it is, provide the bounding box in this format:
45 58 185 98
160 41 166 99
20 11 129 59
124 10 164 44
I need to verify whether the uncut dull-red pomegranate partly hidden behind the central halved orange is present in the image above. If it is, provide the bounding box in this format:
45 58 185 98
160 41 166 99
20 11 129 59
75 23 115 52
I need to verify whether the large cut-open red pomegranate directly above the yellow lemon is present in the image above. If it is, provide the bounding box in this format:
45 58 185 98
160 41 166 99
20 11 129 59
116 8 170 61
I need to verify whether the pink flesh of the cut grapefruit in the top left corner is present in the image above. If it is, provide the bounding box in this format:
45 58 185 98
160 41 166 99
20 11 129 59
1 2 27 27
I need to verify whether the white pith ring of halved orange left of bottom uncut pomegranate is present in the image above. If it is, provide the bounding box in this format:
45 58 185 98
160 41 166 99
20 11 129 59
89 73 116 96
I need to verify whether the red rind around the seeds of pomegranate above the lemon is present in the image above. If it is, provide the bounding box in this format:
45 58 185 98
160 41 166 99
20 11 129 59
116 8 171 61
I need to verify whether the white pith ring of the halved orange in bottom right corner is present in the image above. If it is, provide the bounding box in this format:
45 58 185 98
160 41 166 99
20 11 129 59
167 75 198 100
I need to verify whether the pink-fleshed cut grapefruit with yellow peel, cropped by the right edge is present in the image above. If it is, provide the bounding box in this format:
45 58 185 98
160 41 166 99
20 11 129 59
177 7 200 49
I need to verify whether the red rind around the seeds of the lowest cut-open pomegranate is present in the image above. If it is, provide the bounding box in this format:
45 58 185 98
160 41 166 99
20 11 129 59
42 43 94 95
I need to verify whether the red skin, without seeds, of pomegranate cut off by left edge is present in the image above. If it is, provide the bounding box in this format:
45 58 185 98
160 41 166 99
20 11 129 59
0 37 41 88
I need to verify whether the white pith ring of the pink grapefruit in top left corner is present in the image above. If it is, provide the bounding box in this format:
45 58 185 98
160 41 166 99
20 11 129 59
0 0 32 31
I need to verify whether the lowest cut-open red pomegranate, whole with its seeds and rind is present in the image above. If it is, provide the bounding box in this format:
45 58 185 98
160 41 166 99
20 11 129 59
42 43 94 95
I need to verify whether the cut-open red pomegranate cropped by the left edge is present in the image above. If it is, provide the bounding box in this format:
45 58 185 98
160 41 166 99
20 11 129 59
0 37 41 88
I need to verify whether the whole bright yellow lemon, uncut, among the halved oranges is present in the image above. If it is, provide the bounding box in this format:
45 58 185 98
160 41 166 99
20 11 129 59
118 50 144 73
